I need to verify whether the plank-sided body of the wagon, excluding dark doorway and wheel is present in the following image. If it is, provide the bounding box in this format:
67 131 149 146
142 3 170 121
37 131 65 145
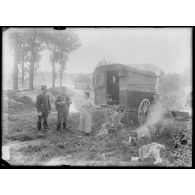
94 64 157 106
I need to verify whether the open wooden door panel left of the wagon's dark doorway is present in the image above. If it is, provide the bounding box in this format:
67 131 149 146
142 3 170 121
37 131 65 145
94 72 106 106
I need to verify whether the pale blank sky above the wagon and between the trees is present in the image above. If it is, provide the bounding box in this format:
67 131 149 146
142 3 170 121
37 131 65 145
4 28 191 73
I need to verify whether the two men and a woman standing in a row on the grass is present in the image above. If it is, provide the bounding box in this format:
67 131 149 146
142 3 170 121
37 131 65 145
36 85 95 135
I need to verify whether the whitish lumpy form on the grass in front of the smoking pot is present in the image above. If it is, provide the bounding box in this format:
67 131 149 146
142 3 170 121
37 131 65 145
131 142 165 164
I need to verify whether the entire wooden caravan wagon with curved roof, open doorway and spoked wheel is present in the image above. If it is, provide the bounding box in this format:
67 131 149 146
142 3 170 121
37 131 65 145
93 64 157 125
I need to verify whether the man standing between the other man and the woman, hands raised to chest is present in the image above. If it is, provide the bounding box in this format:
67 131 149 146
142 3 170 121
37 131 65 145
55 87 72 130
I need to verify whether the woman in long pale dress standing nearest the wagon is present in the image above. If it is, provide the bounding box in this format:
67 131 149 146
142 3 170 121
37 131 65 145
79 92 95 135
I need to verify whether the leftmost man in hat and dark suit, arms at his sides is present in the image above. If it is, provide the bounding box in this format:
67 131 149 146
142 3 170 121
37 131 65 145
36 85 51 130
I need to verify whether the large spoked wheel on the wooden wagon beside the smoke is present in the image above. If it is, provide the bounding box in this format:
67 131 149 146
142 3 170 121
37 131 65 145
137 99 151 125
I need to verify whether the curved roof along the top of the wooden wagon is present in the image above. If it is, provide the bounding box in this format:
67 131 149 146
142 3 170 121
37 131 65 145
94 64 157 76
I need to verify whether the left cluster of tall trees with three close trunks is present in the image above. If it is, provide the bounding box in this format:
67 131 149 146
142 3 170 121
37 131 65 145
10 28 43 89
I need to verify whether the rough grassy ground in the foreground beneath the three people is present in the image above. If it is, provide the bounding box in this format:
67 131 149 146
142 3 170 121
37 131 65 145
3 89 190 166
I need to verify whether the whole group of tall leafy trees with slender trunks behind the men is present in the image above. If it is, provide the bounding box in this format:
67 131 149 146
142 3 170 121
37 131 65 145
9 28 81 90
